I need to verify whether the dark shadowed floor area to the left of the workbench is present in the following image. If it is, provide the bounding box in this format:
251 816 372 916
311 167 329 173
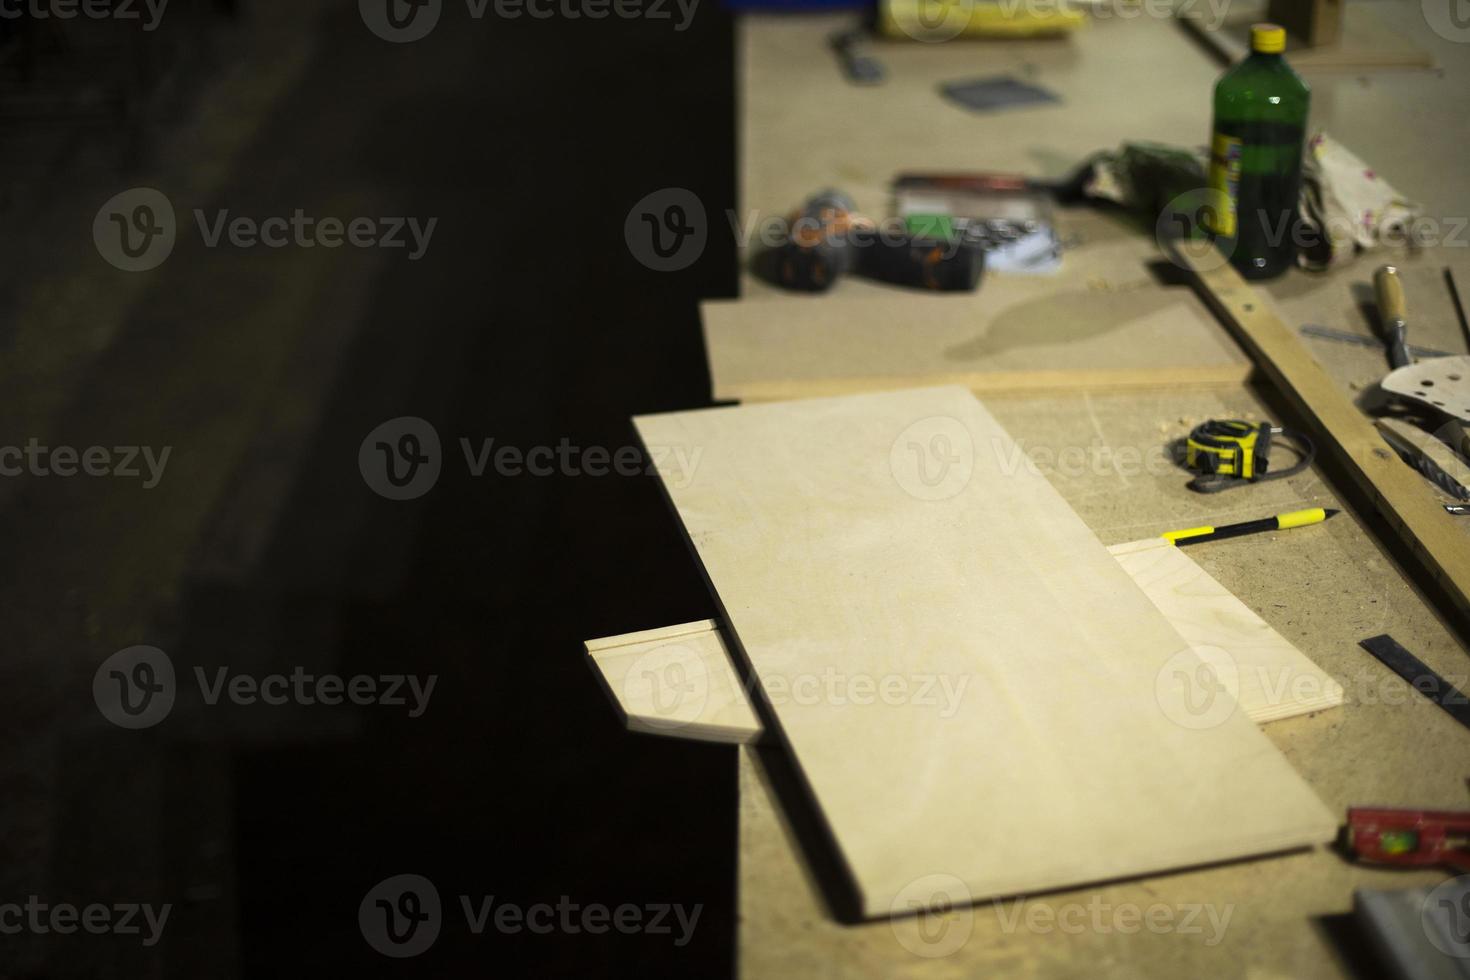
0 0 736 979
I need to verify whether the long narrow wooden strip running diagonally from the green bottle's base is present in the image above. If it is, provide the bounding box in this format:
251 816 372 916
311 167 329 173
1175 248 1470 625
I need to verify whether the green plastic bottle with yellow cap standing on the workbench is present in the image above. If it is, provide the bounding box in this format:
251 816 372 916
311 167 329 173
1204 24 1311 279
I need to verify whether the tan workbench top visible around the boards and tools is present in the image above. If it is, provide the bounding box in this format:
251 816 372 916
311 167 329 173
723 3 1470 980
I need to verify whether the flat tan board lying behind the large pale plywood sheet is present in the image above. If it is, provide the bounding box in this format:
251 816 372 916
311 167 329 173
700 287 1251 401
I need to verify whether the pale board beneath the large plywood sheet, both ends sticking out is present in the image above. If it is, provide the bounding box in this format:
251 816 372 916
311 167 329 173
587 538 1344 745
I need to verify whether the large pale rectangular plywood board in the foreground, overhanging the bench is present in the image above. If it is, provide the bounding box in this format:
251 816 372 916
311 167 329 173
635 388 1336 917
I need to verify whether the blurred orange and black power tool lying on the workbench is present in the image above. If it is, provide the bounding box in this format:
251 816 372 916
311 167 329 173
769 191 985 292
